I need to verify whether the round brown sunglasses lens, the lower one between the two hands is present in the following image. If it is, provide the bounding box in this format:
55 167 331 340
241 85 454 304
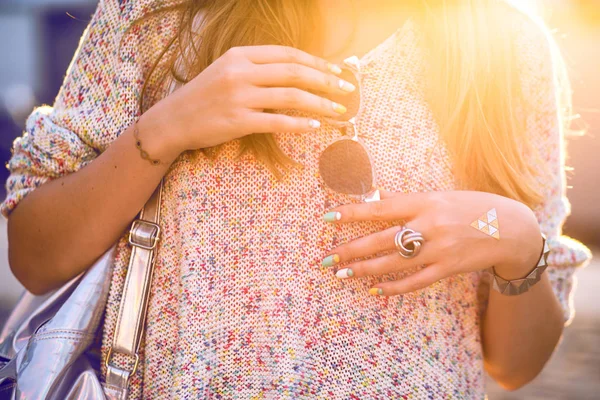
319 139 373 195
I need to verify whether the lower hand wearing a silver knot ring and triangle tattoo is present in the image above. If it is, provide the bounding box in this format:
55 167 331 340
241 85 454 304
323 191 542 296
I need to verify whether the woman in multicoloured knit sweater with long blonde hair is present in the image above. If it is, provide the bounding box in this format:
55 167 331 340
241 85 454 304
2 0 589 399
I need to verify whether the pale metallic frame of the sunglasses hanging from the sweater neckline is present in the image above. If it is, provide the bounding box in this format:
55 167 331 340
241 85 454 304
319 56 381 203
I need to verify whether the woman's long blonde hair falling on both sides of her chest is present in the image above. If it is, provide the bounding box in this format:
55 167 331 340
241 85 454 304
132 0 571 207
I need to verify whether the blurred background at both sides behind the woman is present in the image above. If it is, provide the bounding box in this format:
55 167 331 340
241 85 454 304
0 0 600 400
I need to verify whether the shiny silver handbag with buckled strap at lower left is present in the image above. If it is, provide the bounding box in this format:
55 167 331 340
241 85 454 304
0 181 162 400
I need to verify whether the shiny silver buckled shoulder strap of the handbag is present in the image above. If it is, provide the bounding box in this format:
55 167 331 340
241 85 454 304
104 180 163 400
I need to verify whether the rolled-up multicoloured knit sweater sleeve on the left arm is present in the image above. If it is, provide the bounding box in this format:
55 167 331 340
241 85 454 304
0 0 131 217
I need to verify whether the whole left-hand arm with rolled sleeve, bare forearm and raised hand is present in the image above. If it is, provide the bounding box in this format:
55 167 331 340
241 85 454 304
2 0 353 293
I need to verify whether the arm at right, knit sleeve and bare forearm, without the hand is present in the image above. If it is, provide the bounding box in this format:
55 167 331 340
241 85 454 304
482 16 590 389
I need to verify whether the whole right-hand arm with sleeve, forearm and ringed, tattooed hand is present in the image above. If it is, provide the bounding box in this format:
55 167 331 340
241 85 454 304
314 9 590 389
